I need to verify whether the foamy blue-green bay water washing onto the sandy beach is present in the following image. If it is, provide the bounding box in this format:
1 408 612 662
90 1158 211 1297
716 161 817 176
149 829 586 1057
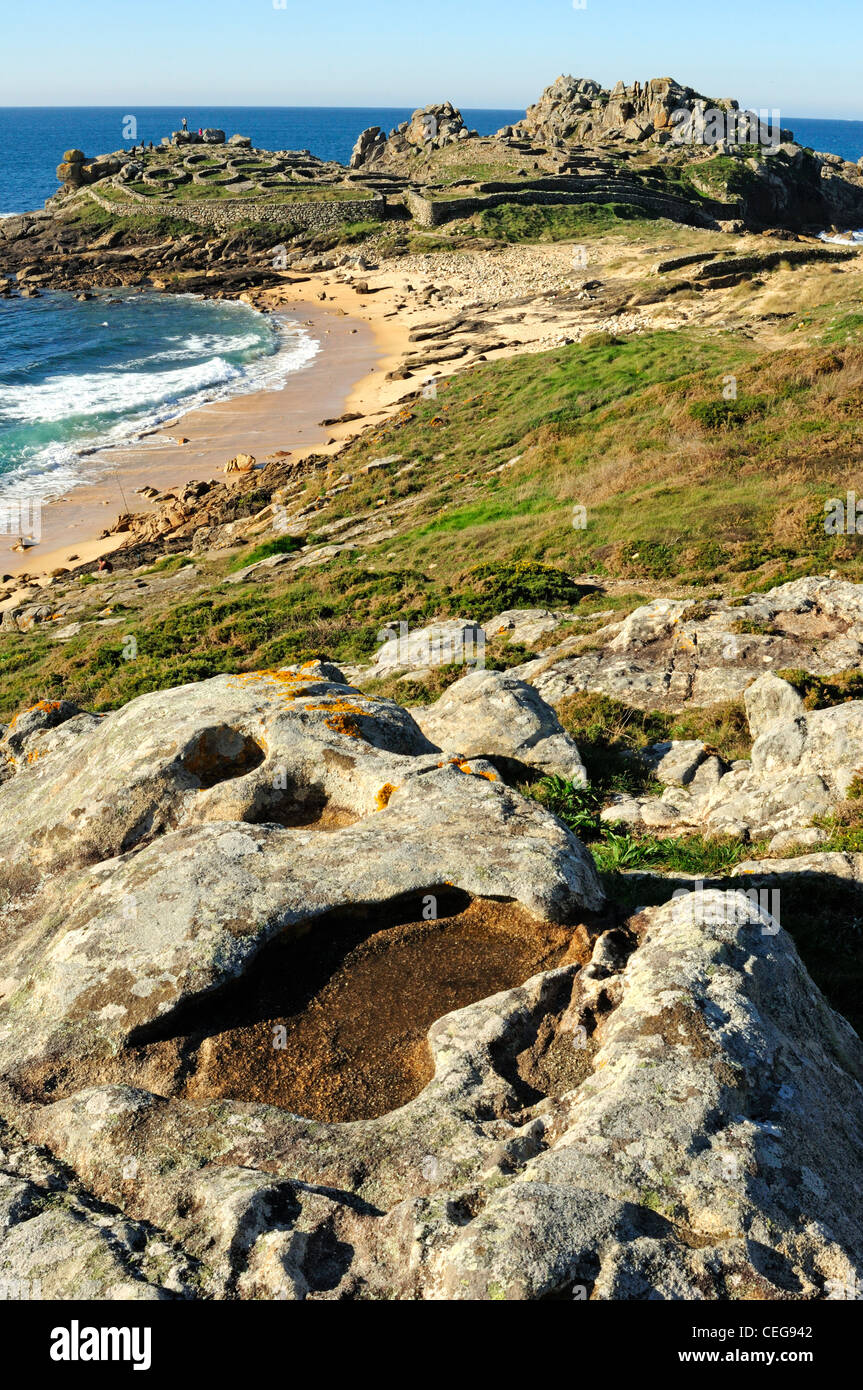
0 291 320 506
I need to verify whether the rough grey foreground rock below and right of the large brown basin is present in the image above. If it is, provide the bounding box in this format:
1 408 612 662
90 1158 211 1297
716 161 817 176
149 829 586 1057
0 892 863 1301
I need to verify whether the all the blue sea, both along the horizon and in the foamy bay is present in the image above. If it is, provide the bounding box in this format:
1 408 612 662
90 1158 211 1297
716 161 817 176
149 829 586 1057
0 107 863 502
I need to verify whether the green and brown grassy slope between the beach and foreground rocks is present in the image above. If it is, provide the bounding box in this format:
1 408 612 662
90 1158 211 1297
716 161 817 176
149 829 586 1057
0 322 863 716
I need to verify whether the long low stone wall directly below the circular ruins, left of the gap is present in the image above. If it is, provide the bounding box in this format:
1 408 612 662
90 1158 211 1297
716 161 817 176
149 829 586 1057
86 188 386 232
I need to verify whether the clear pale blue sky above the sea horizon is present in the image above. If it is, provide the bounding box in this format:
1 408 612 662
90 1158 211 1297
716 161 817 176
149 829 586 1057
6 0 863 120
